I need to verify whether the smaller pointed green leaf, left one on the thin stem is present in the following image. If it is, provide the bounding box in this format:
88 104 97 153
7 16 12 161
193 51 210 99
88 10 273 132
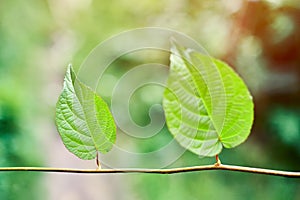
56 66 116 160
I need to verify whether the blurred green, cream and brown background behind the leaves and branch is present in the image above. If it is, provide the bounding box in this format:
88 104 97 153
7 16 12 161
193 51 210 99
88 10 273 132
0 0 300 200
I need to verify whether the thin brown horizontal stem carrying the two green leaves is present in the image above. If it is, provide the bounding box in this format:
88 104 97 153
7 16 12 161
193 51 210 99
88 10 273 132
0 163 300 178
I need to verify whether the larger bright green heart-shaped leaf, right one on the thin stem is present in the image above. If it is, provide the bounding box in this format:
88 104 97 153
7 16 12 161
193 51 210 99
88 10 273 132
163 44 253 156
